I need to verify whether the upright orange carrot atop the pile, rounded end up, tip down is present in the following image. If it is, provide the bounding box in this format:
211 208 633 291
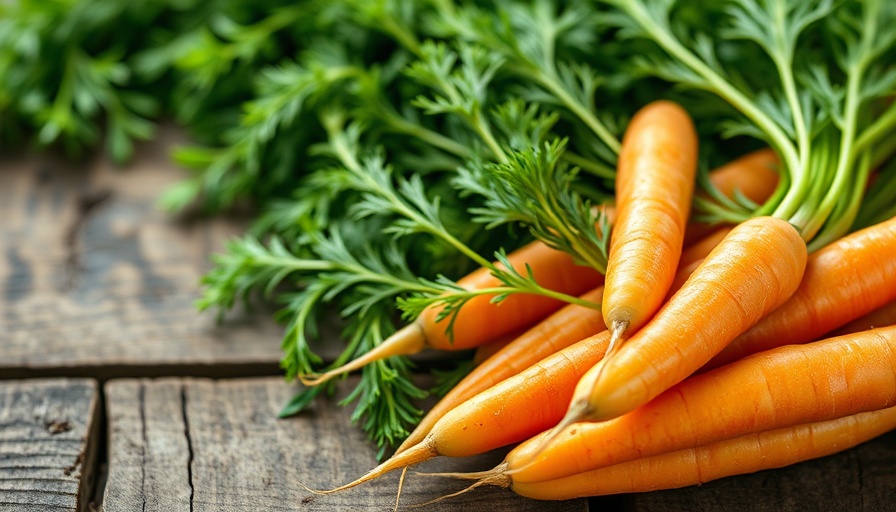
601 101 697 350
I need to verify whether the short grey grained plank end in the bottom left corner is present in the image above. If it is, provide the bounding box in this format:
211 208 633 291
0 379 99 512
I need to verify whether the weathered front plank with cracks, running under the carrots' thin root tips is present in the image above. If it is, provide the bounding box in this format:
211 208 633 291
103 378 587 512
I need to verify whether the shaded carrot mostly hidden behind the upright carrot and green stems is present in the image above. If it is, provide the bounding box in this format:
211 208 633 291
684 148 780 245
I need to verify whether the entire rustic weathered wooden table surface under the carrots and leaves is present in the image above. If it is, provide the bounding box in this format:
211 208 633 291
0 131 896 512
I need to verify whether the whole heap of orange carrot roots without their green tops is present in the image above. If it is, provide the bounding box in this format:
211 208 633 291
292 100 896 506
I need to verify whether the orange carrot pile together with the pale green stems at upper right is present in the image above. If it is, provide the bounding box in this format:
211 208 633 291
258 0 896 499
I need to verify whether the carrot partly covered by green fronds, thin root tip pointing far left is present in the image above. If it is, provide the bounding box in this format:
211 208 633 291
300 241 603 386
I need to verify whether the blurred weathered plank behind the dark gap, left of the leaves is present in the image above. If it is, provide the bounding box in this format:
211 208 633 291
0 131 290 378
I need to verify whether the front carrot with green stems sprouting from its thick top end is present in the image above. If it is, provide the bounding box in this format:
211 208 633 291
555 217 807 428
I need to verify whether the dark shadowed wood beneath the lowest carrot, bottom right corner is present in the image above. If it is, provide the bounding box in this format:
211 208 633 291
624 431 896 512
